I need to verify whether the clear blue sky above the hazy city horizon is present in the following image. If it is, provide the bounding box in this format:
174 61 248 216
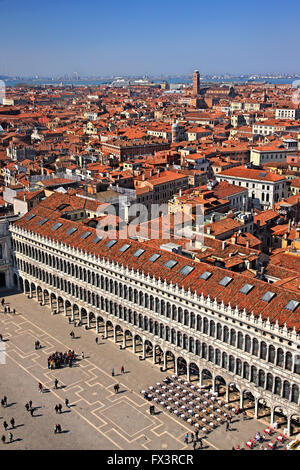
0 0 300 76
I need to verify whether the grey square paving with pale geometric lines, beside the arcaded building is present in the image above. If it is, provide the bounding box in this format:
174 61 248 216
0 292 292 450
